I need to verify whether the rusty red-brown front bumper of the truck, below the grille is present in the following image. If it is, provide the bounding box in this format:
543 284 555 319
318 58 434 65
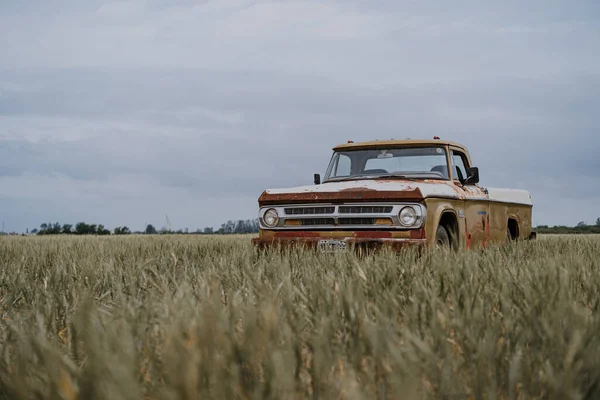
252 230 427 250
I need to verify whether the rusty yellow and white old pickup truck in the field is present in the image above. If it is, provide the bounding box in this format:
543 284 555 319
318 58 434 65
252 137 535 251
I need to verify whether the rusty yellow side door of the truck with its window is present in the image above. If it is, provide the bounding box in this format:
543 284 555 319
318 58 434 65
450 149 490 249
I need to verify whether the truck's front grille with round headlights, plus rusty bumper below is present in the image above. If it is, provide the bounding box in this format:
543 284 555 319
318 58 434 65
254 201 426 251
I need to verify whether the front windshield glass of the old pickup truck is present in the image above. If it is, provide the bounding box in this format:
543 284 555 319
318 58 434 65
325 147 450 181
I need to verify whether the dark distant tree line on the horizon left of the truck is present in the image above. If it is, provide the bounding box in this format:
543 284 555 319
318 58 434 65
31 219 258 235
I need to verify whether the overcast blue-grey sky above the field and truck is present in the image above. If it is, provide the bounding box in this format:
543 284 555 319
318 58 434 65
0 0 600 231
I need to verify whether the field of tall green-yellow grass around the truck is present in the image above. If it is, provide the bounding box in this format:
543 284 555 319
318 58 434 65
0 236 600 399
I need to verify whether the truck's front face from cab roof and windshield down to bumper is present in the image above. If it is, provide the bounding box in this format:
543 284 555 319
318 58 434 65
253 141 458 251
